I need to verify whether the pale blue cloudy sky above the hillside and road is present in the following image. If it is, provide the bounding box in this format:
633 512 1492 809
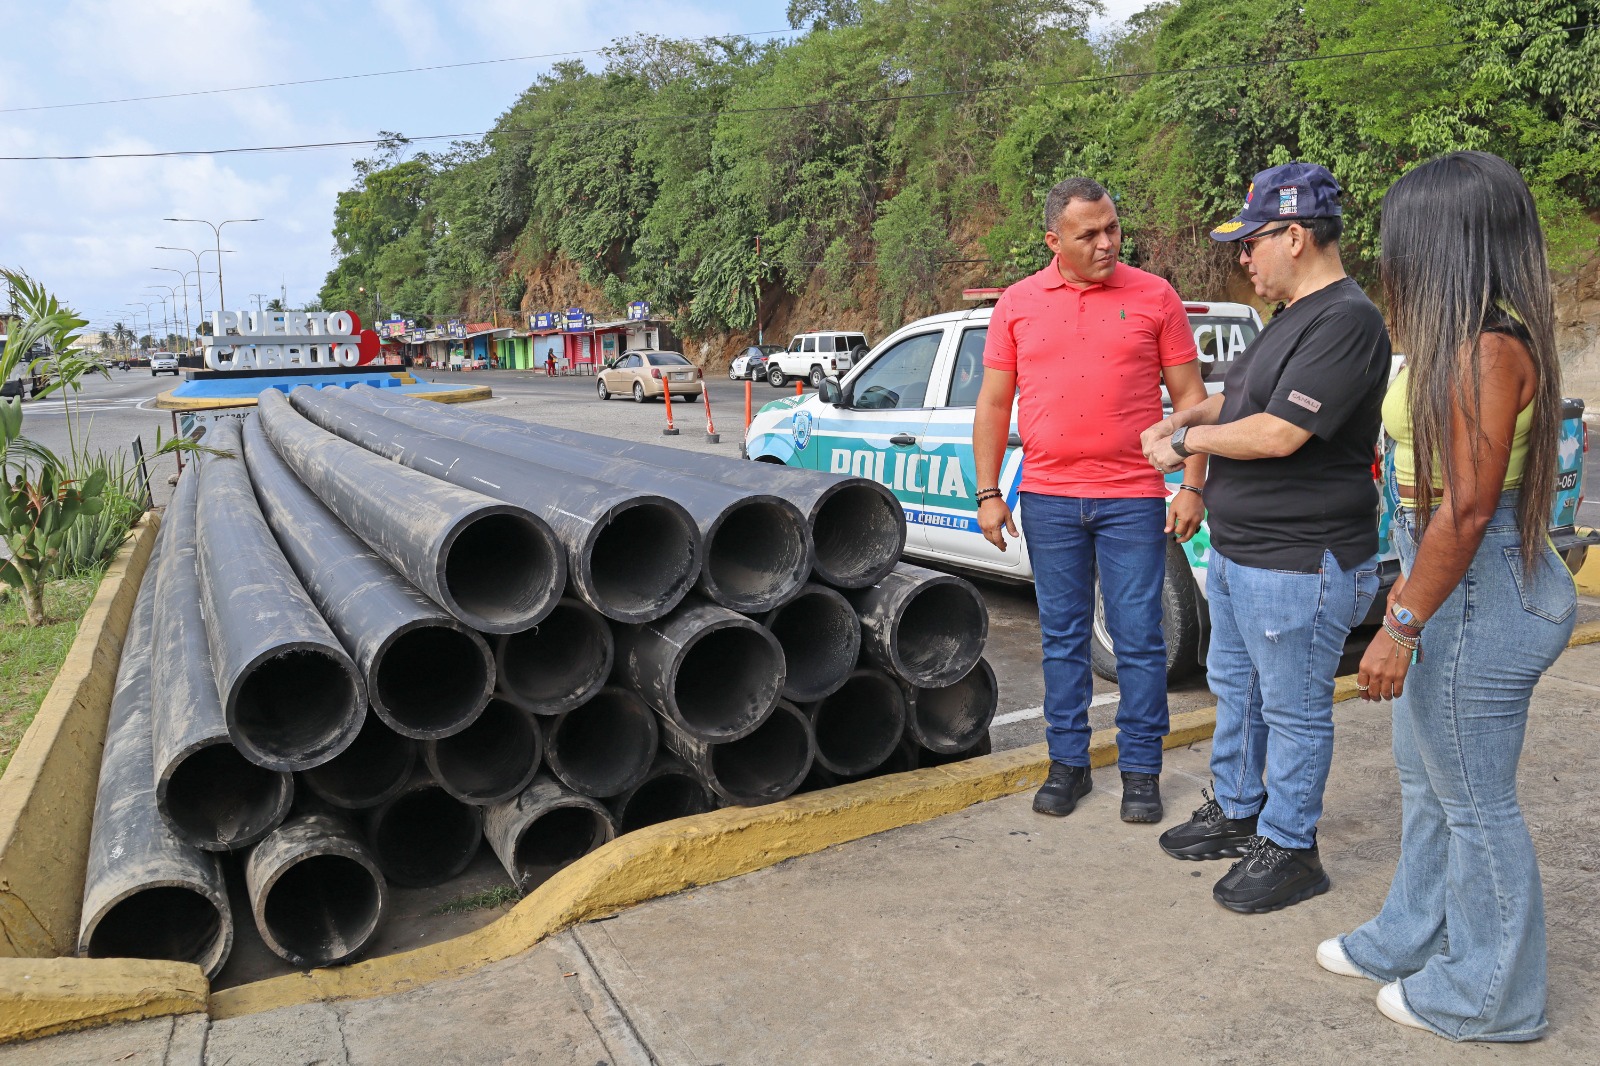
0 0 1147 335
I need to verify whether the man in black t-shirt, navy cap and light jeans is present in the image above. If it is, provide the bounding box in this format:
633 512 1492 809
1142 163 1389 914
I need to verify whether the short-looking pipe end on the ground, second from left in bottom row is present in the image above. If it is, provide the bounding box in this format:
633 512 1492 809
245 815 387 968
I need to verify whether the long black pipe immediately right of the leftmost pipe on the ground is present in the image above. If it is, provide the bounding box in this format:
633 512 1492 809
146 466 294 852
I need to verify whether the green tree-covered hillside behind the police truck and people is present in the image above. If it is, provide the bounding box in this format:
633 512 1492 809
322 0 1600 348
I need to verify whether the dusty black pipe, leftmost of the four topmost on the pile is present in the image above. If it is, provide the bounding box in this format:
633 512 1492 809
258 389 566 632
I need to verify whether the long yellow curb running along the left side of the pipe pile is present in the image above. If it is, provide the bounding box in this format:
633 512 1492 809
0 512 160 960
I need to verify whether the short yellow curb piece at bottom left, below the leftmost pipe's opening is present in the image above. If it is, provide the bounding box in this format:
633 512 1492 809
0 959 208 1044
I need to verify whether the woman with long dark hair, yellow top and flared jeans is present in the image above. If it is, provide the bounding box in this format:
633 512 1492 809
1317 152 1578 1040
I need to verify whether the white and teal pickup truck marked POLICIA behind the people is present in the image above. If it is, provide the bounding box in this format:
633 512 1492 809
744 304 1589 680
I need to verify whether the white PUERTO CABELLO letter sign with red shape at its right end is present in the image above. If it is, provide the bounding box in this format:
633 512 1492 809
200 311 378 370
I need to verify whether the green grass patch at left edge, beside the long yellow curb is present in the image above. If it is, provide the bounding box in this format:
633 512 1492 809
0 573 101 773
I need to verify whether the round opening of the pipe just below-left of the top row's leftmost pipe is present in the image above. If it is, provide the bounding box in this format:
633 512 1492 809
373 626 491 738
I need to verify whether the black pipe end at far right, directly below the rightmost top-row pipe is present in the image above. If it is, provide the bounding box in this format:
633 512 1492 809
848 563 989 687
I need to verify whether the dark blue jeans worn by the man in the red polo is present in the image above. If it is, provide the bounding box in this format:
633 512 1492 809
1022 493 1168 773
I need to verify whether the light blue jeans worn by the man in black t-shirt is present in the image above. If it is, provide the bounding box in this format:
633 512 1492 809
1205 551 1378 848
